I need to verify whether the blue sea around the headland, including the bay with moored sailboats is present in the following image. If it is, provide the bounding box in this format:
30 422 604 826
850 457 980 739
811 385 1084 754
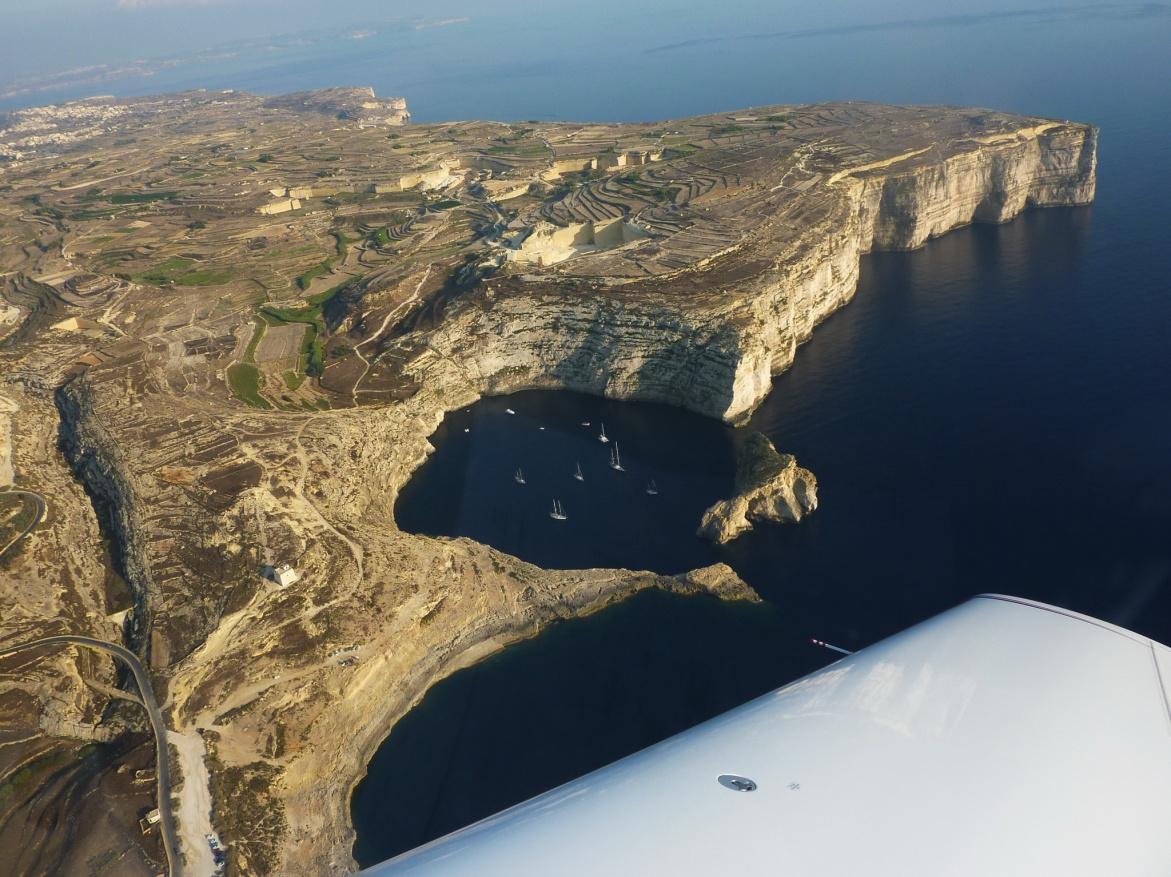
29 0 1171 864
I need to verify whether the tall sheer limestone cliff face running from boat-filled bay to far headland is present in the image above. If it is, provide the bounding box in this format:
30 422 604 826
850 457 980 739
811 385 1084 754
430 122 1097 423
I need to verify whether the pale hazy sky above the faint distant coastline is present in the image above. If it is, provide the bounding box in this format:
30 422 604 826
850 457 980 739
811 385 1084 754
0 0 1091 83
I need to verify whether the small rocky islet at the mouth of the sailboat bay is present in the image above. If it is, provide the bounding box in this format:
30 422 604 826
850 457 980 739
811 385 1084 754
696 432 817 544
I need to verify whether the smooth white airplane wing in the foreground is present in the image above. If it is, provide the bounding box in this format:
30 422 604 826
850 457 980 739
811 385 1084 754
362 595 1171 877
